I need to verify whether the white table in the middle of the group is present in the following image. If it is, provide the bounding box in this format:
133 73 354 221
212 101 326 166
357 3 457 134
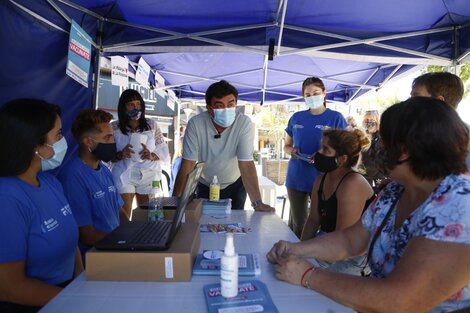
40 211 354 313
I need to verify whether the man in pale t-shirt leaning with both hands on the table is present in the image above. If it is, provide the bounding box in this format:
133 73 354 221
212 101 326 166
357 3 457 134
173 80 274 212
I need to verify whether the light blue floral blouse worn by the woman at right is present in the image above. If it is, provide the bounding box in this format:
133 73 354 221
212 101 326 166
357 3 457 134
362 174 470 312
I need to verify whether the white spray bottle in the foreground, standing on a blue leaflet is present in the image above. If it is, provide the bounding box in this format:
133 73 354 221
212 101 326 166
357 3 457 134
220 233 238 298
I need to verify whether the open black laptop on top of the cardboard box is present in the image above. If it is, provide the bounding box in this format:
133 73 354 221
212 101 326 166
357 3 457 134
95 163 204 251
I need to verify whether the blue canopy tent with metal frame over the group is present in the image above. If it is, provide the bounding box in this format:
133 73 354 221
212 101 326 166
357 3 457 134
0 0 470 140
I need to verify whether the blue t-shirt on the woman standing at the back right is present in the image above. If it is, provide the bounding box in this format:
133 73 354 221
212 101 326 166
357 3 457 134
286 109 348 192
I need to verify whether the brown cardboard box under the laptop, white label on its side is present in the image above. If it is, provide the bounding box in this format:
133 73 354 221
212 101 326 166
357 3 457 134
86 223 200 282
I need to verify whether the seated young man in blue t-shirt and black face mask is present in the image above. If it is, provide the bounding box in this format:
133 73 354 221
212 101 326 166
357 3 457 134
58 109 129 254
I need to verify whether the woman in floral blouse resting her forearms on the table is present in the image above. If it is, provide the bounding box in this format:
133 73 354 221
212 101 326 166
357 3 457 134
267 97 470 312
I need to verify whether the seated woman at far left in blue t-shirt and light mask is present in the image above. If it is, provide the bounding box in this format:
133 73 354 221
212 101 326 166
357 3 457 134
0 99 83 312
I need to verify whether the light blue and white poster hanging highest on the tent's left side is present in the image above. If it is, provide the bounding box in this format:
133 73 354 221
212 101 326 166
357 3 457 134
65 20 92 88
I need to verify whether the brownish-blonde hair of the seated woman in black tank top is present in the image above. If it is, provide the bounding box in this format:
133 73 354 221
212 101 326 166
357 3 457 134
323 128 370 167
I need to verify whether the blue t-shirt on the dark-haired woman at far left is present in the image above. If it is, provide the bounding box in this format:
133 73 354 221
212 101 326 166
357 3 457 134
0 172 78 285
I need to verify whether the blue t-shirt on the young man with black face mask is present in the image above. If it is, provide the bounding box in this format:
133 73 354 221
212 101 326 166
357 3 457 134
58 156 124 251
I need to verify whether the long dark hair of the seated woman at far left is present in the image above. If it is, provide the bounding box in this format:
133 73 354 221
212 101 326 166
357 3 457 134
0 99 60 176
